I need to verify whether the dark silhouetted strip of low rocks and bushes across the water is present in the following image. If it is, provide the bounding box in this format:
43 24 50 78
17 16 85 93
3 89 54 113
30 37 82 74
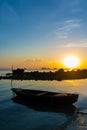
0 68 87 81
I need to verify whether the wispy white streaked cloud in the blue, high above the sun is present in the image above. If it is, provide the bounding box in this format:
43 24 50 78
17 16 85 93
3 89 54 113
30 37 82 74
56 19 81 39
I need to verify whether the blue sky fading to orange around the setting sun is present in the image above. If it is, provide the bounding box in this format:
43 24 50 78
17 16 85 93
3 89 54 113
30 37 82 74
0 0 87 68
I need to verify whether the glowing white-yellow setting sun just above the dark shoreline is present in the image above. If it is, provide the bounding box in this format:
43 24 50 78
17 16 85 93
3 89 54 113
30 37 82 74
63 56 79 68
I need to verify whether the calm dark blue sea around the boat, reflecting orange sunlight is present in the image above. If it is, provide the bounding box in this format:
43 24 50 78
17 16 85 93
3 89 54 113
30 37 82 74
0 69 87 130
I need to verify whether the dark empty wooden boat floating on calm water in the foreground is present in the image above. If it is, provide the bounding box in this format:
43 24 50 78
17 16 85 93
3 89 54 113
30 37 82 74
12 88 79 105
